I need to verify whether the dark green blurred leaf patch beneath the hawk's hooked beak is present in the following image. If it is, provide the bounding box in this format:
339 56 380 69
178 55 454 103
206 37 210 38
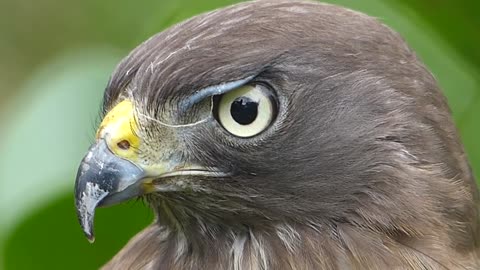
5 193 153 270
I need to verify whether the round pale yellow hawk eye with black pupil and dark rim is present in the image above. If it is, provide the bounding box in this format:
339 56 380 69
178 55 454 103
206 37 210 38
214 84 277 138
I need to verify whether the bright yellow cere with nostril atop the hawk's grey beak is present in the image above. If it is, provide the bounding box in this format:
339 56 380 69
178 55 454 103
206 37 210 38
96 100 140 161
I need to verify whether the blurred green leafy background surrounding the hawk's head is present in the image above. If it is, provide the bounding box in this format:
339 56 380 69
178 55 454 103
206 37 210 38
0 0 480 269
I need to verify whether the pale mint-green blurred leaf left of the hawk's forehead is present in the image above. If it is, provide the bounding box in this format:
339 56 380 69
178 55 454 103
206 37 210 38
0 49 125 262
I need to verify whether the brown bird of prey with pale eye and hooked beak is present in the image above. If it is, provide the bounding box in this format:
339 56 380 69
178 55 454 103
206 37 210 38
75 0 480 270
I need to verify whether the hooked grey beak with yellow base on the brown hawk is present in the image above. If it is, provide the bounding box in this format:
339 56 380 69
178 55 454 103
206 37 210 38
75 100 170 242
